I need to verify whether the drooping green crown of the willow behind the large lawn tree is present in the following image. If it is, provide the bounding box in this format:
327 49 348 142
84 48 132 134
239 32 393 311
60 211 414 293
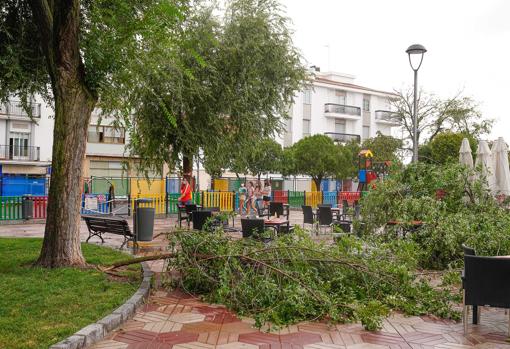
105 0 308 178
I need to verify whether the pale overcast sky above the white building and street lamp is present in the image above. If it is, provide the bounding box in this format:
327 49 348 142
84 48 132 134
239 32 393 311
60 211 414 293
280 0 510 141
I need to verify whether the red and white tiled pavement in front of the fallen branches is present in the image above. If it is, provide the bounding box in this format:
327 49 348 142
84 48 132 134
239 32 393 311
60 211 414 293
89 290 510 349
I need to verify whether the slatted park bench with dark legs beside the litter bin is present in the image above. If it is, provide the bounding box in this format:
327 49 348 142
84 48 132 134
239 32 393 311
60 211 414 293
81 215 136 249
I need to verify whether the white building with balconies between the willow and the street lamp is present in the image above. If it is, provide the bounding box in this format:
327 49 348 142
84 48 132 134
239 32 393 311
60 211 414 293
279 72 398 147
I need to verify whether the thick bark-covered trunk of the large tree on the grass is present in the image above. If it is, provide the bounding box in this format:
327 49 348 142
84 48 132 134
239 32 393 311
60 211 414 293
29 0 97 268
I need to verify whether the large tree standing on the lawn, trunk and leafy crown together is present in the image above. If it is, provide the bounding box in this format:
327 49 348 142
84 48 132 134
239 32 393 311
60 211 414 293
0 0 187 267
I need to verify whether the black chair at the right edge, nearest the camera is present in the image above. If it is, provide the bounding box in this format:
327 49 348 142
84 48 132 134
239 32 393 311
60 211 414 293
463 254 510 334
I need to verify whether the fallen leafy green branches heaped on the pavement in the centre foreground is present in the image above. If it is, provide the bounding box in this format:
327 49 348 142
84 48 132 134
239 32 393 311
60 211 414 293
169 227 459 330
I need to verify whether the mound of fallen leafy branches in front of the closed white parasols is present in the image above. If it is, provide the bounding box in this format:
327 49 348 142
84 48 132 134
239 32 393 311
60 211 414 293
357 164 510 270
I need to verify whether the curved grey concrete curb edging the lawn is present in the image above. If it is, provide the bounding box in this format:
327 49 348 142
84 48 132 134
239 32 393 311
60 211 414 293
50 262 154 349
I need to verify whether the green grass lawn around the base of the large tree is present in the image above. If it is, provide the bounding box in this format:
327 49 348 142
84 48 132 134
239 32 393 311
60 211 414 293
0 238 140 349
